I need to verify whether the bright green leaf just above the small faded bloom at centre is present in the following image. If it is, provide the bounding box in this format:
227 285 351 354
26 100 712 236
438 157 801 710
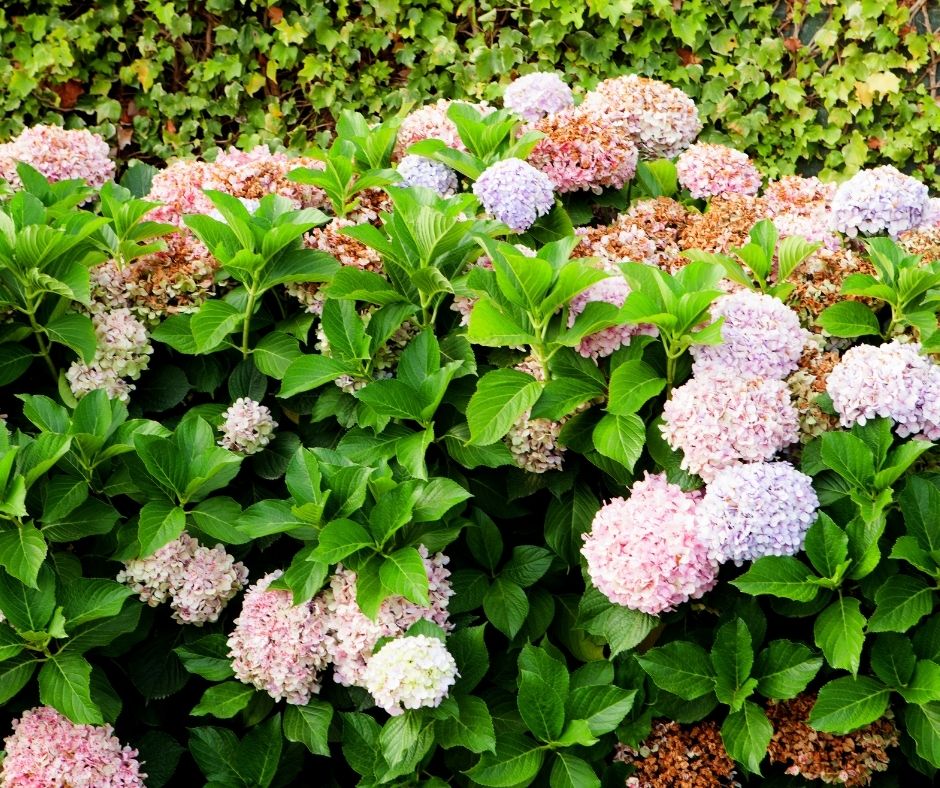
467 369 542 446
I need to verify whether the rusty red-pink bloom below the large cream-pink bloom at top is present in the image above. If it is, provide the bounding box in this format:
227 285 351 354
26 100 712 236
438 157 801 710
528 111 639 194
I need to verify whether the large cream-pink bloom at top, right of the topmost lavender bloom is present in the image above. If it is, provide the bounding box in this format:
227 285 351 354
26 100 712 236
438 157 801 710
580 74 702 159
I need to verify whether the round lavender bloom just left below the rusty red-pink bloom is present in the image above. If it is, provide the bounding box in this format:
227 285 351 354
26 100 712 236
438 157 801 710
473 159 555 233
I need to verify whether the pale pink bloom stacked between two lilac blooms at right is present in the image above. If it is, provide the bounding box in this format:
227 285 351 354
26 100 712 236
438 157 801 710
661 372 800 482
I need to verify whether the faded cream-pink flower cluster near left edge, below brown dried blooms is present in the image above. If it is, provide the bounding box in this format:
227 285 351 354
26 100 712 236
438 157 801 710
66 307 153 402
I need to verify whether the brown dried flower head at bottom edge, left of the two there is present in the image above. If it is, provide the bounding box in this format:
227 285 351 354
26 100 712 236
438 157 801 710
614 720 740 788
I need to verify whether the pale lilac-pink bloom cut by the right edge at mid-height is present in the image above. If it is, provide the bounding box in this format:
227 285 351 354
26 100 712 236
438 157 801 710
826 340 940 440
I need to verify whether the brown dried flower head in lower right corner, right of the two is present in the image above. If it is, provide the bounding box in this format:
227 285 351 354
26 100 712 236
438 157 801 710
767 694 898 788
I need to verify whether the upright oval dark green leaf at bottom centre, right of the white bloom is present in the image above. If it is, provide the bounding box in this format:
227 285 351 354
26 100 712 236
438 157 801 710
516 644 569 742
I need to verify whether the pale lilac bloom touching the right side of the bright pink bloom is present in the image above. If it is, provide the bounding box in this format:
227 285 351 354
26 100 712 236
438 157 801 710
698 462 819 566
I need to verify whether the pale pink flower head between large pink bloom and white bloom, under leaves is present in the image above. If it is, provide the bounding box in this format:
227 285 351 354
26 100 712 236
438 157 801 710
321 547 454 687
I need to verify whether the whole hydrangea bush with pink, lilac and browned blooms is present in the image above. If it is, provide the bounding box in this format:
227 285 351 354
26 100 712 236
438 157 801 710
0 73 940 788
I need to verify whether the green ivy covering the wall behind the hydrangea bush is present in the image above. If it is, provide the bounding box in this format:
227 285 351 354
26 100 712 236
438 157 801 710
0 0 940 186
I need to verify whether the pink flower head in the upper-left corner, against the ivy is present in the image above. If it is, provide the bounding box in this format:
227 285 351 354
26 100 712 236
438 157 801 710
0 126 114 189
